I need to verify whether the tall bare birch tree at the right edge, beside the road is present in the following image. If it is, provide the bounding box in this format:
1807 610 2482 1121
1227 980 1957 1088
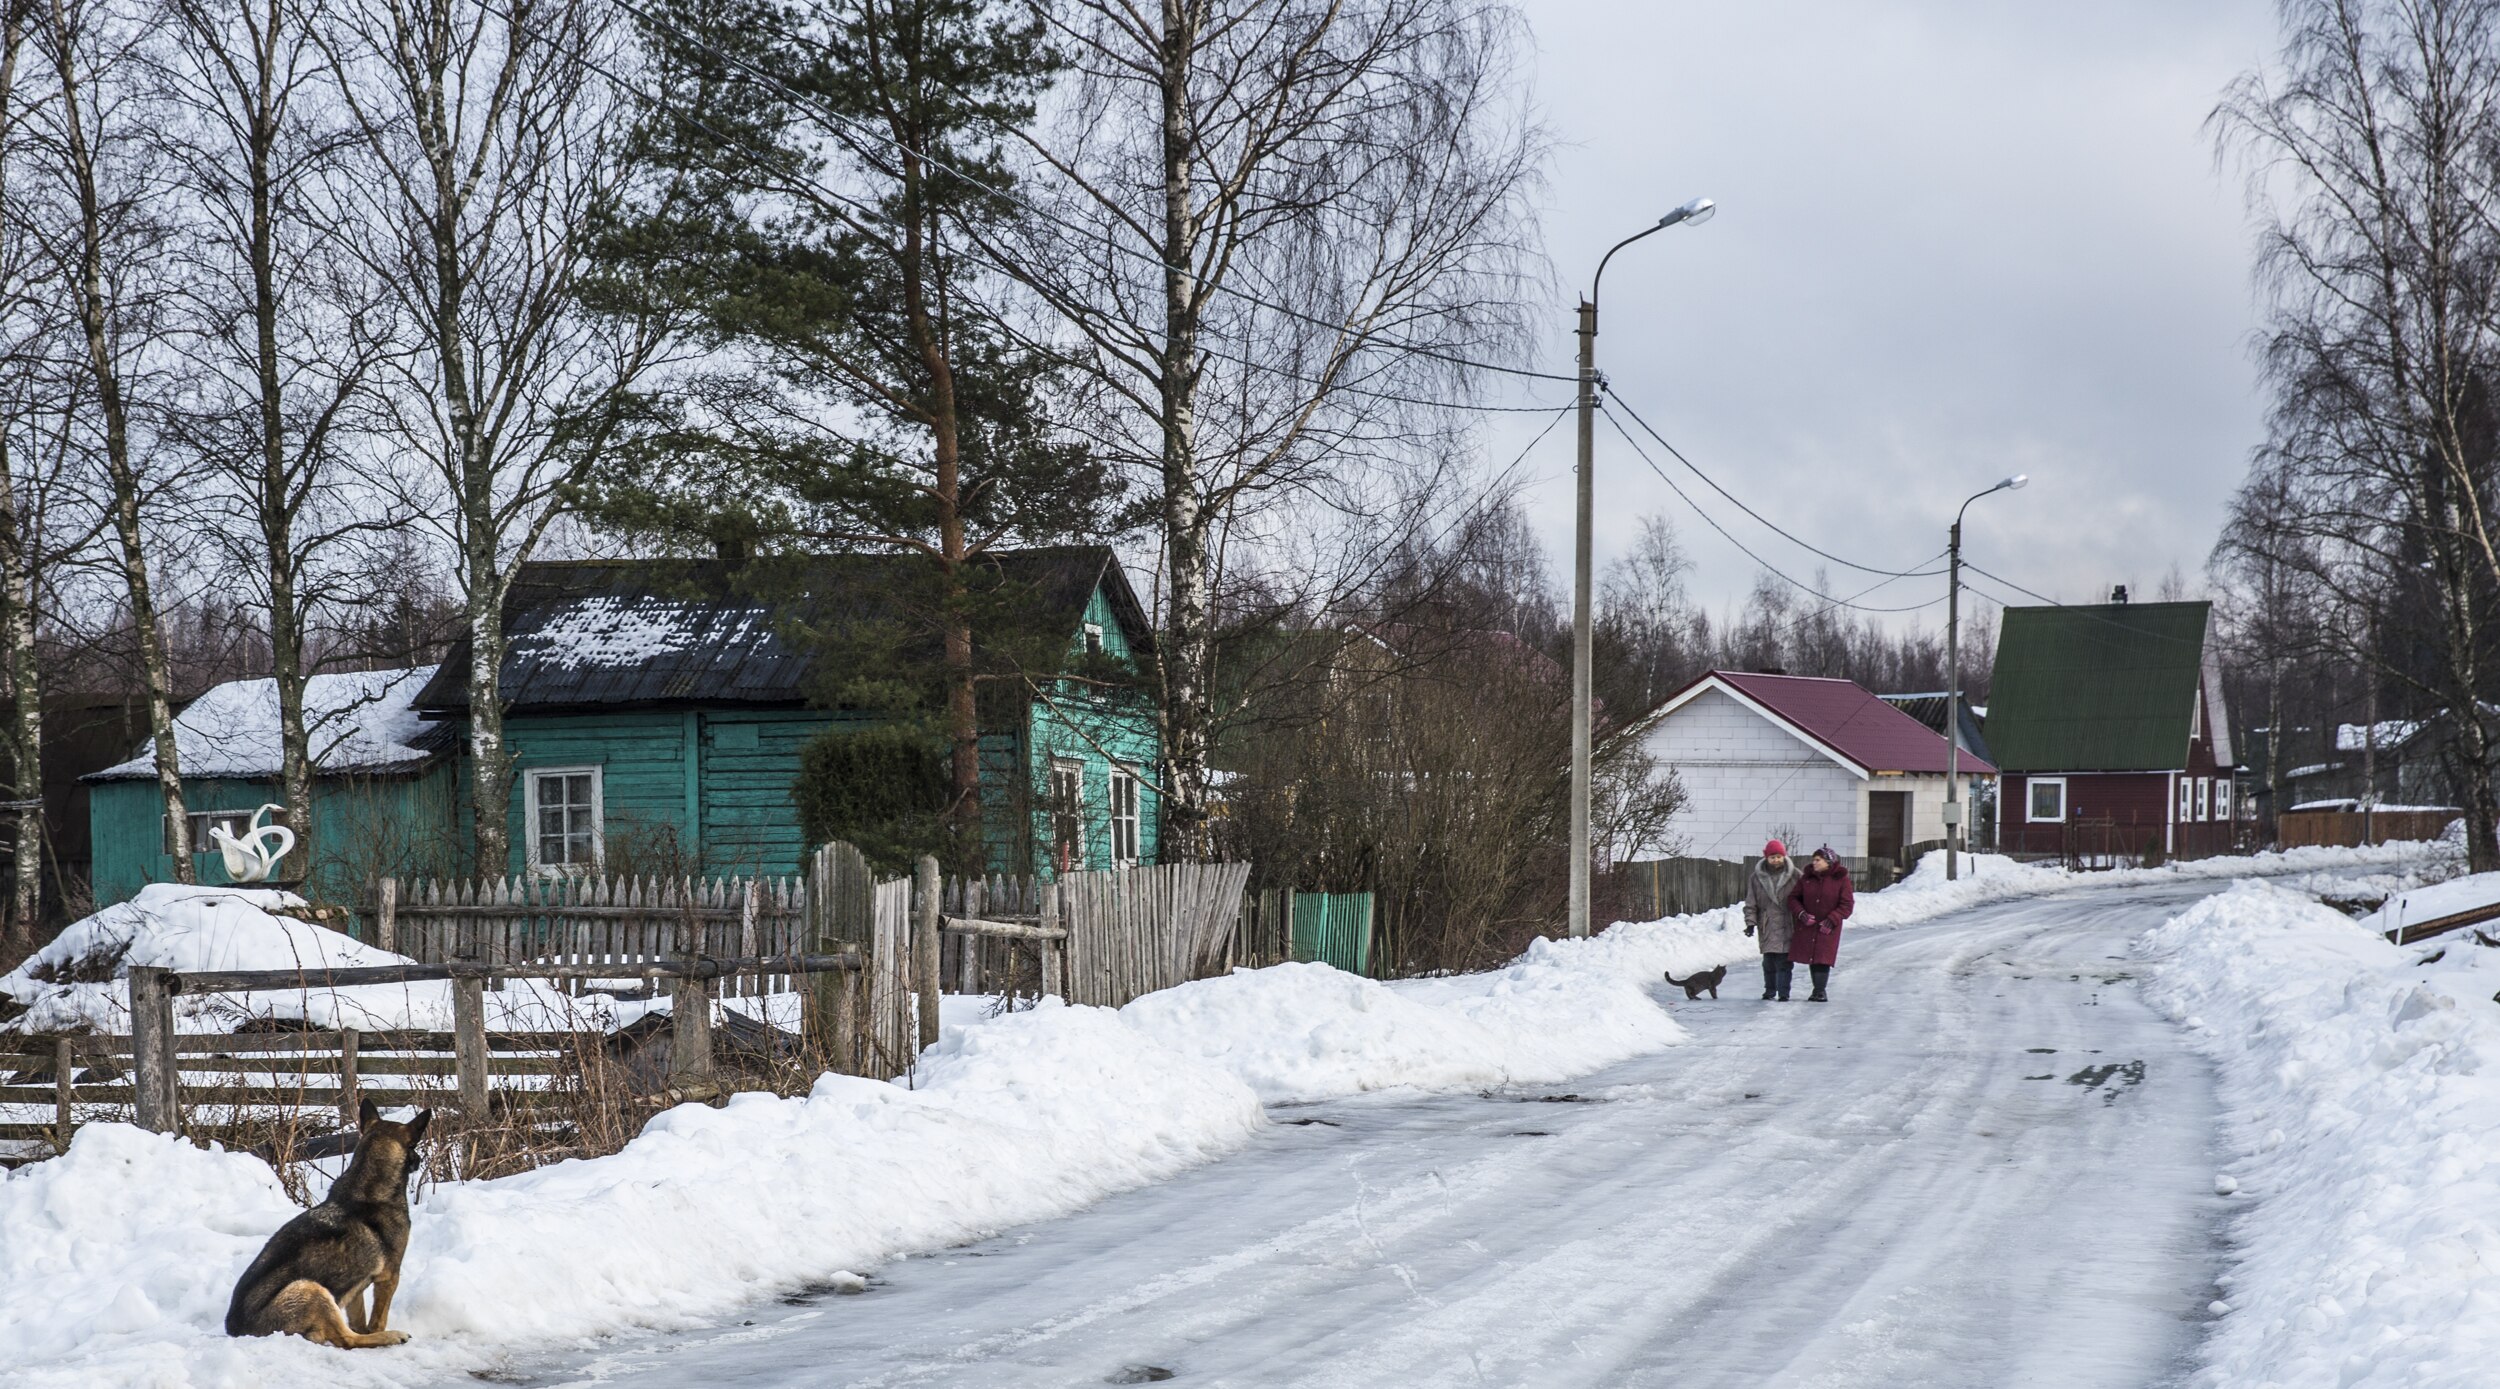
2213 0 2500 872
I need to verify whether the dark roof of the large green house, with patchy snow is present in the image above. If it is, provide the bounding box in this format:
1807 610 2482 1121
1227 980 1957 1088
418 545 1153 714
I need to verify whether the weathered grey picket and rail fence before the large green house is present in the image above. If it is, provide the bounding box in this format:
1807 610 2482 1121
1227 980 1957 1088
0 844 1250 1164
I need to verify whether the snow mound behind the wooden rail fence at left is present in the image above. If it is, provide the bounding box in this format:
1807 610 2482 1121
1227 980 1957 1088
0 882 613 1034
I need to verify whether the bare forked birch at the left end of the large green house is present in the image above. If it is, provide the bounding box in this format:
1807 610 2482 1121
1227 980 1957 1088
323 0 665 872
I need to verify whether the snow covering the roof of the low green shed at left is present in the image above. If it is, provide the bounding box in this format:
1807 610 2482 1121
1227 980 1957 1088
90 665 435 782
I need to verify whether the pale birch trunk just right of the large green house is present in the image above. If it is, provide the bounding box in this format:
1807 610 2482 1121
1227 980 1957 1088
1155 0 1215 862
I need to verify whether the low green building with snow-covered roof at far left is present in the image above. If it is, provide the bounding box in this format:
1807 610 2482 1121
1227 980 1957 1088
85 665 458 904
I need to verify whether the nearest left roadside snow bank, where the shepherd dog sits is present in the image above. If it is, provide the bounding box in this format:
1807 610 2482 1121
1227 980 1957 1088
0 1007 1263 1389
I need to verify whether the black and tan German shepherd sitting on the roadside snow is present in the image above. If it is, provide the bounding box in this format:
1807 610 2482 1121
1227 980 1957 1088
225 1099 435 1349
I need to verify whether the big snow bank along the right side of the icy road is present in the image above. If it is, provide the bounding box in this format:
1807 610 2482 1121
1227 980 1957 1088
2138 882 2500 1389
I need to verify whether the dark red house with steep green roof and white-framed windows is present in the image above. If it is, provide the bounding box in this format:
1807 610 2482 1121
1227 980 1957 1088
1988 602 2238 859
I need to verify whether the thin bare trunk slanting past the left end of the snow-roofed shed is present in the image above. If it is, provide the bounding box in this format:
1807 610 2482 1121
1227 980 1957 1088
53 0 198 882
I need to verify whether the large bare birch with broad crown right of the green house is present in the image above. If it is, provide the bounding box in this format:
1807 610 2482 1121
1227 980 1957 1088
993 0 1543 857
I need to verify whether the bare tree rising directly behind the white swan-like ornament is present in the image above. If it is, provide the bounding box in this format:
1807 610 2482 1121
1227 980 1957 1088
158 0 393 859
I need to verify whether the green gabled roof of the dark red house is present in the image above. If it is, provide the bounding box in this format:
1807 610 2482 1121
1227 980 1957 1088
1988 602 2213 772
